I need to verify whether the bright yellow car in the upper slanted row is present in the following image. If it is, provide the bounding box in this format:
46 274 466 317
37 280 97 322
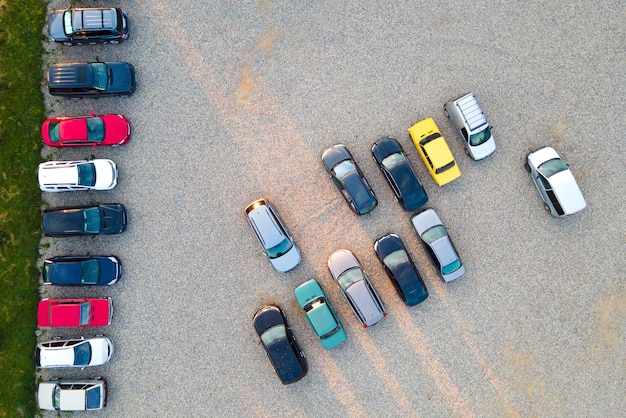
409 118 461 186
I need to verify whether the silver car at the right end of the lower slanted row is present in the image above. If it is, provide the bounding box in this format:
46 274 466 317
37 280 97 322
411 209 465 282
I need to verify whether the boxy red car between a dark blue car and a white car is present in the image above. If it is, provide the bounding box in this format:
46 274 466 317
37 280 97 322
37 298 113 328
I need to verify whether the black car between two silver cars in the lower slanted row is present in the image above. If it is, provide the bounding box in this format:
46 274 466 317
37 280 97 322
374 234 428 306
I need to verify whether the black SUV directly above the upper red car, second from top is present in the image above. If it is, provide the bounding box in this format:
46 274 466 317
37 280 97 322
46 62 137 98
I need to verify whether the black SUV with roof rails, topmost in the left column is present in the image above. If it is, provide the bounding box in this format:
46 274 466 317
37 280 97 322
48 8 129 46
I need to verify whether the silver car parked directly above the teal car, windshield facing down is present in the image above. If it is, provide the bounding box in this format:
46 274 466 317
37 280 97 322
245 199 300 273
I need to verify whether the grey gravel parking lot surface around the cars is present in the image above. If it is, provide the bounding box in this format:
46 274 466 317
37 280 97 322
40 0 626 417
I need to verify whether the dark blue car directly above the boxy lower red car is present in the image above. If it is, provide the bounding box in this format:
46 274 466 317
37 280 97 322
42 255 122 286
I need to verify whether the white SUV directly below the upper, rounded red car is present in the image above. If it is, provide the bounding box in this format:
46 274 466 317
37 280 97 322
38 159 117 192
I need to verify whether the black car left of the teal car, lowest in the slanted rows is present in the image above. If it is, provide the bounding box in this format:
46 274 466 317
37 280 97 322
252 305 308 385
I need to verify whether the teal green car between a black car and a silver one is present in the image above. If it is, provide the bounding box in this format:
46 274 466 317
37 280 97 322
294 279 347 350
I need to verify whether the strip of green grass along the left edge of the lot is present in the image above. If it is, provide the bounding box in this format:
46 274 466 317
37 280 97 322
0 0 46 417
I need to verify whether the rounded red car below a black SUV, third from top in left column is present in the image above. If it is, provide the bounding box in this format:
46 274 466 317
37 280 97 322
41 112 130 147
